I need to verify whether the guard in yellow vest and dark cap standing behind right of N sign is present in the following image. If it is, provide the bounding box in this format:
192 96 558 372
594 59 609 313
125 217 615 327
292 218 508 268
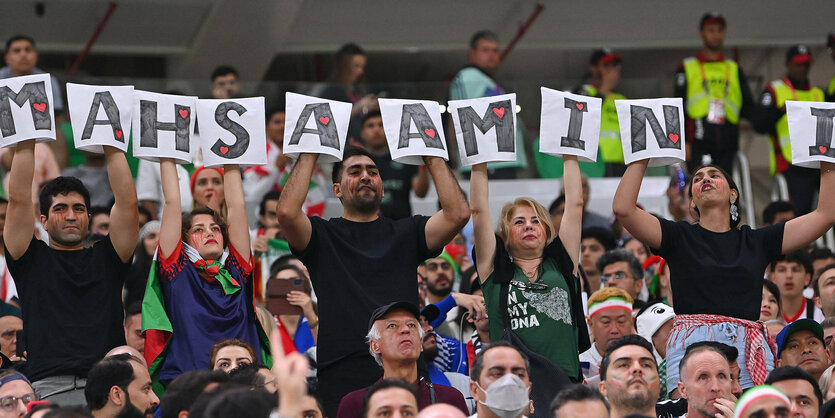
675 12 756 173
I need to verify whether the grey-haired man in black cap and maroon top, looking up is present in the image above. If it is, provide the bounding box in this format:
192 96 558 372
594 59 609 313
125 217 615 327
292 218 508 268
336 301 469 418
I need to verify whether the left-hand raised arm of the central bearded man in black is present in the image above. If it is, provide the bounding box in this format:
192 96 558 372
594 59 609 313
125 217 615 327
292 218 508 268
277 154 319 251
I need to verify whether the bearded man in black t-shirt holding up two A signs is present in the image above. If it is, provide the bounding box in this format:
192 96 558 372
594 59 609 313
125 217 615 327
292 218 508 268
278 148 470 416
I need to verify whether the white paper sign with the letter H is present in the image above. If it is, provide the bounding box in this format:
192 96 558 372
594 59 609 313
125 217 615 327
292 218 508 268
132 90 203 164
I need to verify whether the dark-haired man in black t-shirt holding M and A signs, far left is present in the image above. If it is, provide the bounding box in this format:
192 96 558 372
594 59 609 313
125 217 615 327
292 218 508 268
3 140 139 405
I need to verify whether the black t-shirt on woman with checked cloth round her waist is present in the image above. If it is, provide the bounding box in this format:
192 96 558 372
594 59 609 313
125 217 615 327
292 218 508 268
653 220 785 321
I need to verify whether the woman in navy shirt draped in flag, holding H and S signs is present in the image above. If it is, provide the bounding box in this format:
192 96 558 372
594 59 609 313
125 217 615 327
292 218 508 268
142 158 264 384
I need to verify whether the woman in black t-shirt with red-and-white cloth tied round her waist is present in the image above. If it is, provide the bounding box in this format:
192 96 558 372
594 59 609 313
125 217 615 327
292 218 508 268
613 160 835 396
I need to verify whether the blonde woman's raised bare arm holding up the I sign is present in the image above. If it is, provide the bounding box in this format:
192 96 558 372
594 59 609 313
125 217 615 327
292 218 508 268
559 155 583 272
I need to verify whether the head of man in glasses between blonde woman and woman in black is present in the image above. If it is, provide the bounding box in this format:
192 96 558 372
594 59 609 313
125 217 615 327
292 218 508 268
596 248 646 309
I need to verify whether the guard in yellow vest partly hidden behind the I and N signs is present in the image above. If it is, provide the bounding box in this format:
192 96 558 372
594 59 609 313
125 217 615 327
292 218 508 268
574 48 626 177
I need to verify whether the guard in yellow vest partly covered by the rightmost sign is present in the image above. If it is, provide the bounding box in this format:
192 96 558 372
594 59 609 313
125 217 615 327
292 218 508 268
754 45 824 216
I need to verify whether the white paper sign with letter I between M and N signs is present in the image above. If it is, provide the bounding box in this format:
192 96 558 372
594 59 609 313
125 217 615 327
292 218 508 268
539 87 603 162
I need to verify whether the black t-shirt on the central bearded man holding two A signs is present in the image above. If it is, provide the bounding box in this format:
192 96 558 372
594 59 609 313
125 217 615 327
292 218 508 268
291 216 440 368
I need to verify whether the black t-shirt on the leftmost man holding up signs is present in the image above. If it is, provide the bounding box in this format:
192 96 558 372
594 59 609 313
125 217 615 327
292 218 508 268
6 236 130 381
